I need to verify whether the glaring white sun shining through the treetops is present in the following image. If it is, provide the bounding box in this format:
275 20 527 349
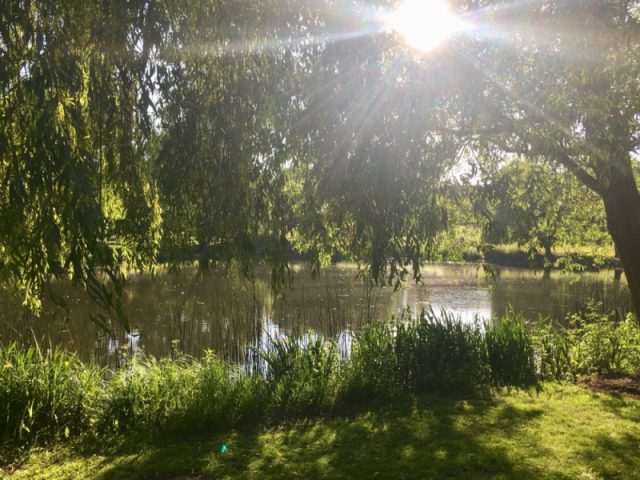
387 0 464 51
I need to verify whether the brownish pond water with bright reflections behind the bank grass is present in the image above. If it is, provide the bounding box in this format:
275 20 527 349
0 264 631 366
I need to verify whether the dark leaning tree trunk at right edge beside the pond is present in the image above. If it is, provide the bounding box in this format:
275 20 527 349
601 174 640 315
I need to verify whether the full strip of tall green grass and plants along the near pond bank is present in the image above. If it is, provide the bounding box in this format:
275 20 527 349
0 310 640 458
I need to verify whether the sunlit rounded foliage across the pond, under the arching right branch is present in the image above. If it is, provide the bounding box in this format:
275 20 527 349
472 159 610 266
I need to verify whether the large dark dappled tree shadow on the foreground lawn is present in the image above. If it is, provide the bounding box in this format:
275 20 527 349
89 398 569 480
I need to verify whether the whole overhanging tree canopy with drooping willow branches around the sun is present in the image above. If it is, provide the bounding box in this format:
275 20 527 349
0 0 640 322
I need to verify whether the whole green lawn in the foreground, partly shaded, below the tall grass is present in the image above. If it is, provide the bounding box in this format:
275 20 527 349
5 384 640 480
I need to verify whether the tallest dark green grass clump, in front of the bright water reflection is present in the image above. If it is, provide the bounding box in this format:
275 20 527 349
352 309 490 394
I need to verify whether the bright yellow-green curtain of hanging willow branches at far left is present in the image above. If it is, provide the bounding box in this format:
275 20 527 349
0 1 165 324
